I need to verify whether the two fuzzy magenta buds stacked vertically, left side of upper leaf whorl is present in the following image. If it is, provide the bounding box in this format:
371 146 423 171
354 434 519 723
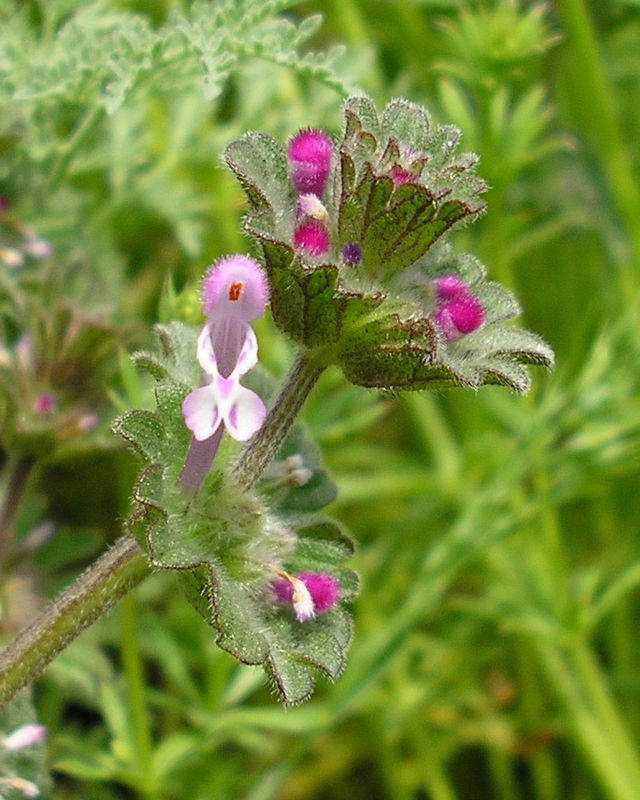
287 130 333 258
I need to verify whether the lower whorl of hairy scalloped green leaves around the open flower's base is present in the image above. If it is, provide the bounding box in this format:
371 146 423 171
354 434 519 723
114 322 358 704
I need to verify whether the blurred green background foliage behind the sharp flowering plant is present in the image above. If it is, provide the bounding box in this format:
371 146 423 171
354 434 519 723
0 0 640 800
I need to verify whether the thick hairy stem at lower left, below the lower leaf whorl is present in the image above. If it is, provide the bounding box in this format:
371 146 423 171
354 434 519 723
0 536 149 707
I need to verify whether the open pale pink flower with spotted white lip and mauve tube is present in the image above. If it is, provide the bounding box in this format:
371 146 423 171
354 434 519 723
182 255 269 488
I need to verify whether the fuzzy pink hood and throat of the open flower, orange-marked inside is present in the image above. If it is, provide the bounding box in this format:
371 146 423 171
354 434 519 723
201 255 269 378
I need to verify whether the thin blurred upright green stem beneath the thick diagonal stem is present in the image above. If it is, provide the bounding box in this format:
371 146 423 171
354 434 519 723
120 592 153 796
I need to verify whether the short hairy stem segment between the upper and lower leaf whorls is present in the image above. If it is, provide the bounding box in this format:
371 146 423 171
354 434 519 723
233 351 324 489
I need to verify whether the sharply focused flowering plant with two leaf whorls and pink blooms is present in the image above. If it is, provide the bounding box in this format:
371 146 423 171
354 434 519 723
0 97 553 704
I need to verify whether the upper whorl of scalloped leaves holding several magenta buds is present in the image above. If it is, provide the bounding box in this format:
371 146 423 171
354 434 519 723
225 96 553 392
